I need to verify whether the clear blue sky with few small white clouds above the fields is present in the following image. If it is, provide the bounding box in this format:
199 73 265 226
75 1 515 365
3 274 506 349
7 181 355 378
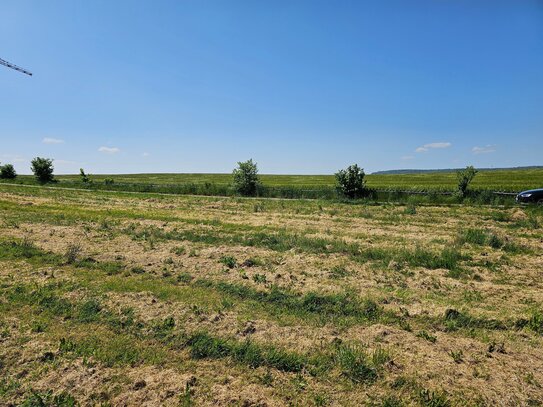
0 0 543 174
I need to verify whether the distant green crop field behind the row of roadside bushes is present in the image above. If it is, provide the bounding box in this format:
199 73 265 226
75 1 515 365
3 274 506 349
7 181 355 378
4 169 543 192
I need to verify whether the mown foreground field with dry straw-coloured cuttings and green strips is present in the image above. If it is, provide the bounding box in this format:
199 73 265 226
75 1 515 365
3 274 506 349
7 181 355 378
0 185 543 407
